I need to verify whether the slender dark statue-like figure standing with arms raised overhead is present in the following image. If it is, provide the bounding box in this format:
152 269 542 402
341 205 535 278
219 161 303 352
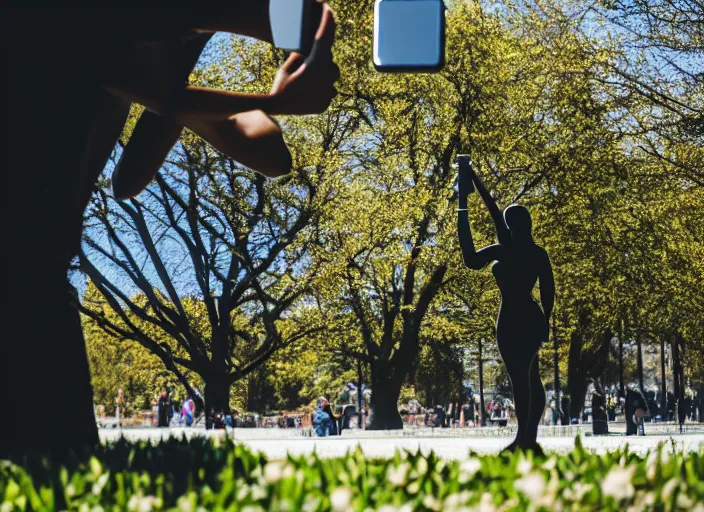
457 156 555 453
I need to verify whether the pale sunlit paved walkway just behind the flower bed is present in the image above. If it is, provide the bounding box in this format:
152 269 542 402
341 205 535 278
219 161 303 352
100 428 704 459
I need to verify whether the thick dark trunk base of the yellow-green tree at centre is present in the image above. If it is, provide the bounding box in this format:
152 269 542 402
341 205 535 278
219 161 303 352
367 363 403 430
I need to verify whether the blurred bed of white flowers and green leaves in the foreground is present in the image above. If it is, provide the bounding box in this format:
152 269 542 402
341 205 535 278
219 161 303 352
0 439 704 512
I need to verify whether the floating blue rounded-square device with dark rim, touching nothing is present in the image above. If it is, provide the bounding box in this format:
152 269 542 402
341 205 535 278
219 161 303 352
373 0 445 73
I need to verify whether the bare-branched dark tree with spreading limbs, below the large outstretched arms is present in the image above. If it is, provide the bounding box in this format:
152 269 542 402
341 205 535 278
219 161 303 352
81 134 336 422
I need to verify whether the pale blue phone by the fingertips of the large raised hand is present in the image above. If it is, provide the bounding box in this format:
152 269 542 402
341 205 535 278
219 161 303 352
269 0 323 55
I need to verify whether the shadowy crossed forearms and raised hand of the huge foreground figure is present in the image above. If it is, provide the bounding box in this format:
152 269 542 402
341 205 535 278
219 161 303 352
105 4 340 199
